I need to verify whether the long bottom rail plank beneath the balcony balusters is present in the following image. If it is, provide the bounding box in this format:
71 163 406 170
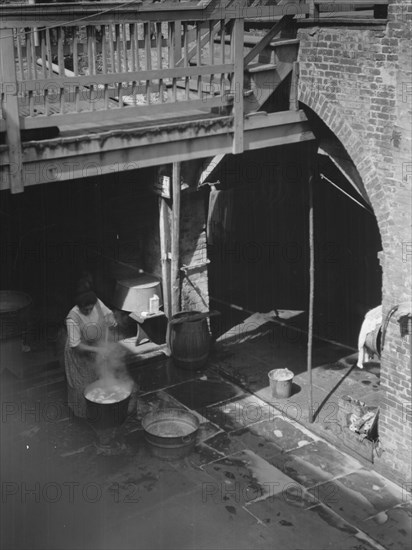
20 96 231 130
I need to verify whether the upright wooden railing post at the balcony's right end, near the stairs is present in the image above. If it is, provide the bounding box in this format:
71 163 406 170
232 19 244 154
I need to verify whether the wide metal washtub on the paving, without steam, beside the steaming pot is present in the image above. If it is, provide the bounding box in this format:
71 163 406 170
142 408 200 459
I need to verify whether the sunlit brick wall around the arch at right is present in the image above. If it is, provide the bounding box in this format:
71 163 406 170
298 0 412 482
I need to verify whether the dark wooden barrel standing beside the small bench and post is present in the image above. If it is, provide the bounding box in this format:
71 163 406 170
169 311 210 370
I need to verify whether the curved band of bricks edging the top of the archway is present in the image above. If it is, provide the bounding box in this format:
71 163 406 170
299 83 386 246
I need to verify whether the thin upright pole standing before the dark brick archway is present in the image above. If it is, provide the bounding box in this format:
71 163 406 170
307 174 315 423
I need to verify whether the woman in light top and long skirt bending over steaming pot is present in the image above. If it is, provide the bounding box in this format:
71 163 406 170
64 289 117 418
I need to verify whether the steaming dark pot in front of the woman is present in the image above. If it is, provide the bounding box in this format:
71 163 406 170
84 380 132 430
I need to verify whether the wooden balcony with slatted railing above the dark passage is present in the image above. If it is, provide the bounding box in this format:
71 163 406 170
0 0 386 193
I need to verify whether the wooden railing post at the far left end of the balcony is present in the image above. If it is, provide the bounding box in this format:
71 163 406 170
0 29 24 193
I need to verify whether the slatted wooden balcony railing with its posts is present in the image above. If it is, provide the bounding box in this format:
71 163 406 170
0 0 383 192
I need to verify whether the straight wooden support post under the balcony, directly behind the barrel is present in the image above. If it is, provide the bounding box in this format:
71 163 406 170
171 162 180 315
